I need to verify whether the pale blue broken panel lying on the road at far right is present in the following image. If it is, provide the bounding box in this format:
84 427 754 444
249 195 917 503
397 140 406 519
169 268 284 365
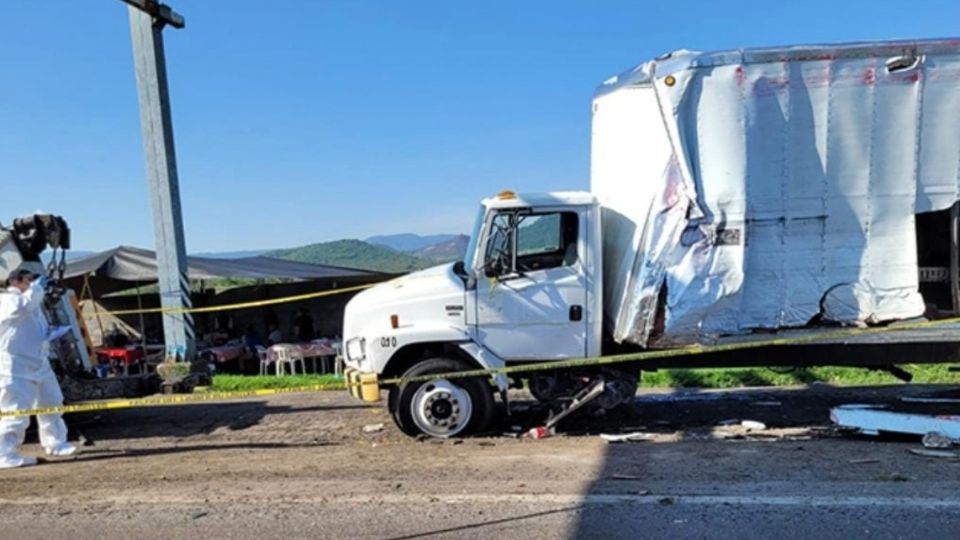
830 405 960 439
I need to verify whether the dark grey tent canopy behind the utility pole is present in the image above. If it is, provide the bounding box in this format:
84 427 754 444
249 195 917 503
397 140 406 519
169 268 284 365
64 246 388 296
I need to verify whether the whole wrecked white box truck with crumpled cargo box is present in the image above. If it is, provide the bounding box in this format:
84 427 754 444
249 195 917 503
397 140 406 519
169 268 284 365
344 40 960 437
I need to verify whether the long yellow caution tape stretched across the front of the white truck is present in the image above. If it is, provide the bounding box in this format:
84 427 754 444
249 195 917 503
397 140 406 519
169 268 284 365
0 310 960 418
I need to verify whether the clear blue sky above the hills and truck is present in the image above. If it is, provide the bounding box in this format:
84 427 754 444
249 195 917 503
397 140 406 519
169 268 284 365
0 0 960 252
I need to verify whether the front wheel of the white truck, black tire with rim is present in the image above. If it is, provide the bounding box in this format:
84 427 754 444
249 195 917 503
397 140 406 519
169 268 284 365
388 358 494 438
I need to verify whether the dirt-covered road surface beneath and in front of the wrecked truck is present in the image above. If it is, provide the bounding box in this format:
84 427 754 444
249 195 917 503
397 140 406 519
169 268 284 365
0 385 960 540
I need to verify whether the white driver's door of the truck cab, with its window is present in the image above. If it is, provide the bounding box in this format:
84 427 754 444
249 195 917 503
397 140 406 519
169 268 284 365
475 208 587 360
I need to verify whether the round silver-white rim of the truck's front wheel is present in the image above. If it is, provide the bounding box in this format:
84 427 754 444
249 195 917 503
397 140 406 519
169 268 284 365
410 379 473 437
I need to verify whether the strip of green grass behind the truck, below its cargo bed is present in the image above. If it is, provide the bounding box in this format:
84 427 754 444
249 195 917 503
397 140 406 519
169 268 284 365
641 364 960 388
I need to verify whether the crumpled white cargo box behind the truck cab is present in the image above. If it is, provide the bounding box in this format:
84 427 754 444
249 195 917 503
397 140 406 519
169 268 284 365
591 40 960 344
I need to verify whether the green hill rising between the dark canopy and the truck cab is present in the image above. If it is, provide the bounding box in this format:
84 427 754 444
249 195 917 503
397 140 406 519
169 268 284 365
266 240 436 274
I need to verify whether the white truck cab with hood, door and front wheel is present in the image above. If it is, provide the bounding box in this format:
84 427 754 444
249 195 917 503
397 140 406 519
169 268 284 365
344 191 603 437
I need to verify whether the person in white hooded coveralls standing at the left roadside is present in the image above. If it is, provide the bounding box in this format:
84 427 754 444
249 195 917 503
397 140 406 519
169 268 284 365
0 269 77 469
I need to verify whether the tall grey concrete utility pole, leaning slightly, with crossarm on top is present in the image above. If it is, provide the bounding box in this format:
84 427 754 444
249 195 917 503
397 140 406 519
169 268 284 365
122 0 196 361
